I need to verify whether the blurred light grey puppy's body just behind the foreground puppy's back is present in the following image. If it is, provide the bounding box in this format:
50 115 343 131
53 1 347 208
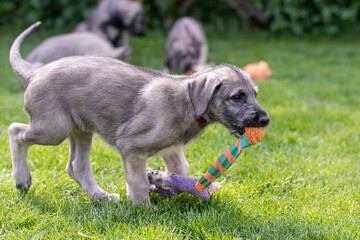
26 32 130 65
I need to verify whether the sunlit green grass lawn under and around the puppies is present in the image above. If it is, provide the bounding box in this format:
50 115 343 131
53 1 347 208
0 27 360 239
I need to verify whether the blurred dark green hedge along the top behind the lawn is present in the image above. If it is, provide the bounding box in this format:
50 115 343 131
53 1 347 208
0 0 360 35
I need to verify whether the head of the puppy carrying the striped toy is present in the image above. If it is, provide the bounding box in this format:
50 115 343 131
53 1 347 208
188 65 270 136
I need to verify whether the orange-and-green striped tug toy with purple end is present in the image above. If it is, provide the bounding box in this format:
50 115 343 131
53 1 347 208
148 127 265 201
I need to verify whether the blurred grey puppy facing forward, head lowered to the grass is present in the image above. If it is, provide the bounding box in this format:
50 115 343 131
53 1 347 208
165 17 208 73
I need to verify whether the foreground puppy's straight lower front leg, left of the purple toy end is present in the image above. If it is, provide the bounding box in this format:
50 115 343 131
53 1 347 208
123 155 150 205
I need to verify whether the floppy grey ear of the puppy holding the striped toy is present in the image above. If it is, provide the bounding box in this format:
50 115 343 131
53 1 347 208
188 73 221 118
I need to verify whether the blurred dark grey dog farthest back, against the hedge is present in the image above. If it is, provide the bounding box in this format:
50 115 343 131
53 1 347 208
75 0 145 55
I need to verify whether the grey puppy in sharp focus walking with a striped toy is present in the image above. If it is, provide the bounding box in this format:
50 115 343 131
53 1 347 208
9 23 269 204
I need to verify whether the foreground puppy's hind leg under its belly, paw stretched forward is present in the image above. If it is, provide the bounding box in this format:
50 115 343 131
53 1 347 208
66 129 118 201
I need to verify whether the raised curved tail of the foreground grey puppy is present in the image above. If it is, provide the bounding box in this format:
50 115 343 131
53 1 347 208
10 22 41 90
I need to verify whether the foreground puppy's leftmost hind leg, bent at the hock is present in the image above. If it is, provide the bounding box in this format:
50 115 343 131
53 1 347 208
9 117 71 192
